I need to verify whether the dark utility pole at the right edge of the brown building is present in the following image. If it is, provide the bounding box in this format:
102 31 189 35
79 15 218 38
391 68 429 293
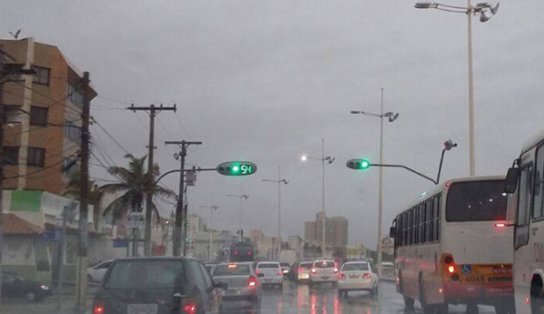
76 72 91 313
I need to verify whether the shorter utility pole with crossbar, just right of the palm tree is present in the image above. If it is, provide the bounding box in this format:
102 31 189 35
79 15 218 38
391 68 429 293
164 141 202 256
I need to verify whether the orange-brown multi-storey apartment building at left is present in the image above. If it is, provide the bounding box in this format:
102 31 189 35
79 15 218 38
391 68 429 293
0 38 97 195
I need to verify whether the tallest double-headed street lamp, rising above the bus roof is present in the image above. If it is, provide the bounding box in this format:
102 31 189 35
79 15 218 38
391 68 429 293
415 0 499 176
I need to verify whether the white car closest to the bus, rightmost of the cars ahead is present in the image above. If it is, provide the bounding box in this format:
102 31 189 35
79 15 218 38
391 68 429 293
337 261 379 297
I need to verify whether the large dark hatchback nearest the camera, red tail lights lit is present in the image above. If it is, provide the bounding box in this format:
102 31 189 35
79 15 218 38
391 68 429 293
92 257 226 314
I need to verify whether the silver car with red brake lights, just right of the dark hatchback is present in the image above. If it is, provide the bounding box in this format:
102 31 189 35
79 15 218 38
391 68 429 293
213 262 264 308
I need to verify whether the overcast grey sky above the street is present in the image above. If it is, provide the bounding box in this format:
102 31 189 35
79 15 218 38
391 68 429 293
0 0 544 247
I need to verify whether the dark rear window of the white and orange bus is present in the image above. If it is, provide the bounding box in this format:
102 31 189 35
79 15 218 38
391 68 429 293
446 180 507 222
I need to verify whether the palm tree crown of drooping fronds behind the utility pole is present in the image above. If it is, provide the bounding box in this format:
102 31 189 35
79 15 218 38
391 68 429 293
99 154 175 223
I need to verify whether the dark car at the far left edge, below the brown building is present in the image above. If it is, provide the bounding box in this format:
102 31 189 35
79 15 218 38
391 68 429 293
1 271 53 302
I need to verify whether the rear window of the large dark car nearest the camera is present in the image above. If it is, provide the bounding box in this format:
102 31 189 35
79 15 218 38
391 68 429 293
104 260 185 289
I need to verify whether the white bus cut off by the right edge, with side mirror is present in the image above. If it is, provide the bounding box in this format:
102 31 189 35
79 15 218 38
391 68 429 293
505 133 544 314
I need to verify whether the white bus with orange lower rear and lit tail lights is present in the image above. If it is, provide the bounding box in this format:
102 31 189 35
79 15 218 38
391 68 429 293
390 177 514 313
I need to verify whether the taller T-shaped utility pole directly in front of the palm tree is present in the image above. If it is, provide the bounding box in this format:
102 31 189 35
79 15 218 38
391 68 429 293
127 104 176 256
